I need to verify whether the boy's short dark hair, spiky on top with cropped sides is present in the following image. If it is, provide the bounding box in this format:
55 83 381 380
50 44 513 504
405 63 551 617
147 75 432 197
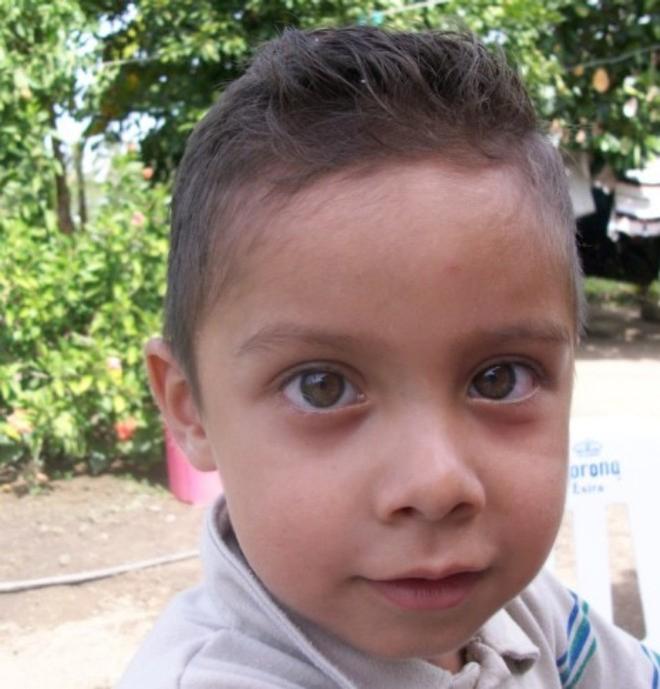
165 26 581 393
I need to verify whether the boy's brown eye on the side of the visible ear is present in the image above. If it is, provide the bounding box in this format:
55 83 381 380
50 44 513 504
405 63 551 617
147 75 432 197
282 368 363 411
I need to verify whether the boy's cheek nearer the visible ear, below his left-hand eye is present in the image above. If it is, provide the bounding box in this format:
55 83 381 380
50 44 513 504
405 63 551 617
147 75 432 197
213 408 374 532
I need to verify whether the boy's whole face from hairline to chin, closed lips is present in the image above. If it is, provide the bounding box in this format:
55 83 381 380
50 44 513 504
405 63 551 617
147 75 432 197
157 162 574 668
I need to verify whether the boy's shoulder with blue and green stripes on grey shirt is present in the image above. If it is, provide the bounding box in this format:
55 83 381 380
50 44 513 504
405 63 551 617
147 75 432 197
507 572 660 689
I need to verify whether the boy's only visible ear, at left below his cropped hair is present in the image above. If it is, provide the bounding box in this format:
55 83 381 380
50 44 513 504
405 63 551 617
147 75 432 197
144 337 216 471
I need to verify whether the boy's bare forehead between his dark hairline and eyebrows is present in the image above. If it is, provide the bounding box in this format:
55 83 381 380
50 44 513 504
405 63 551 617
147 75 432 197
199 161 572 354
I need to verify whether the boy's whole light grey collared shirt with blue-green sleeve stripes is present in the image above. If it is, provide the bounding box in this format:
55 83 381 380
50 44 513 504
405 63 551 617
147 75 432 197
117 498 660 689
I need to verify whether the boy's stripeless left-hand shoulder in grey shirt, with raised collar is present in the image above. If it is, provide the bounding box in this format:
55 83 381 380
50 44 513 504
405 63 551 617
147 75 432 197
116 500 342 689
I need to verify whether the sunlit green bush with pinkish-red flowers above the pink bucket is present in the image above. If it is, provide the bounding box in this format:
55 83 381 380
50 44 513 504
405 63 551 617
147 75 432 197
0 157 168 472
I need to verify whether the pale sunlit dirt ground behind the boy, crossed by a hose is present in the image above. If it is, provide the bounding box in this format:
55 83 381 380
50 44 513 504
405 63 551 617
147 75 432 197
0 309 660 689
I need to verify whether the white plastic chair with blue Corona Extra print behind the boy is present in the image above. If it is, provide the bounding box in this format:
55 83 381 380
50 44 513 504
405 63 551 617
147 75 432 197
556 417 660 649
